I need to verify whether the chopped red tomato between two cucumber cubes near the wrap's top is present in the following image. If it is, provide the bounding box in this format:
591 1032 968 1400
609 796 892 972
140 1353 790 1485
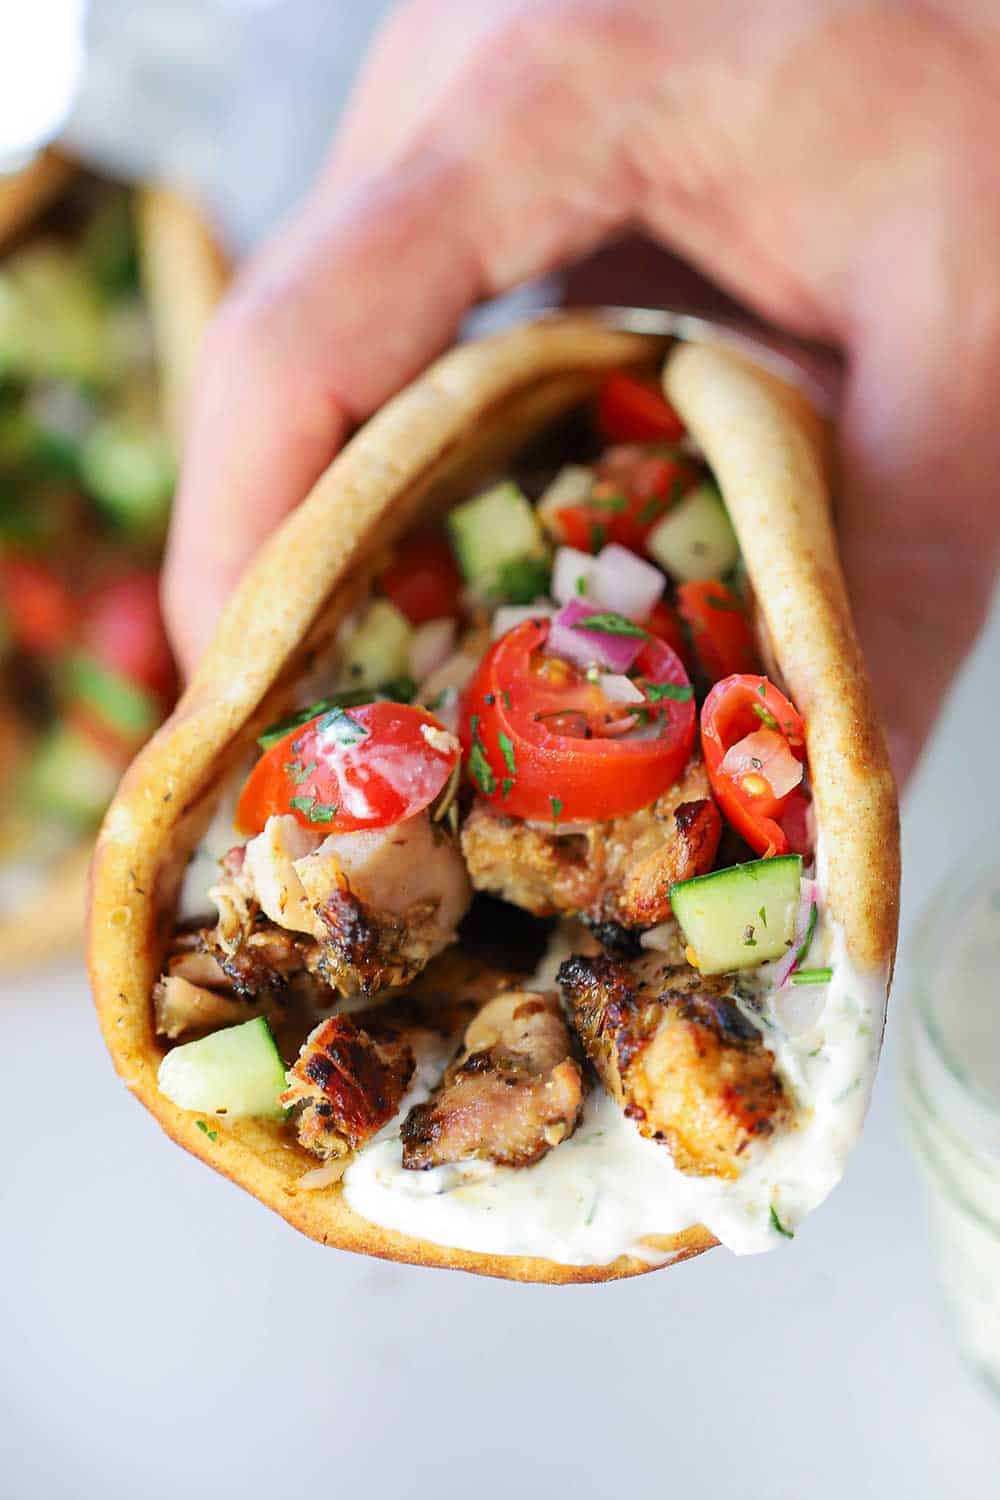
556 444 699 554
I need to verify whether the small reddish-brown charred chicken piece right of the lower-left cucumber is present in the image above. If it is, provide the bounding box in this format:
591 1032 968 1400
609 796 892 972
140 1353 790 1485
280 1013 414 1160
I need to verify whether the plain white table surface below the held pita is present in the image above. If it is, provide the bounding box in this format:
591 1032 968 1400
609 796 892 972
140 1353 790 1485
0 588 1000 1500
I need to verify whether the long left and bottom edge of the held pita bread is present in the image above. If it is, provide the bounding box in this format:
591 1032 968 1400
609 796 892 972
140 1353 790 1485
88 317 899 1283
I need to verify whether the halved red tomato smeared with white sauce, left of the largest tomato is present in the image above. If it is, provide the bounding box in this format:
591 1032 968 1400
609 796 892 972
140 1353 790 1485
235 702 459 834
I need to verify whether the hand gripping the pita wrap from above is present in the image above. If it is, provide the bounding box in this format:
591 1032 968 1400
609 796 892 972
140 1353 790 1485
165 0 1000 774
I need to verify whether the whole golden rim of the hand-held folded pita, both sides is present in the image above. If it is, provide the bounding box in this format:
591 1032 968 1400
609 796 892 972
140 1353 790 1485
88 315 898 1283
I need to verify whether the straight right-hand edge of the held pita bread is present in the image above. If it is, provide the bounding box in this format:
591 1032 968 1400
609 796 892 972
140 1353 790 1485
664 344 900 977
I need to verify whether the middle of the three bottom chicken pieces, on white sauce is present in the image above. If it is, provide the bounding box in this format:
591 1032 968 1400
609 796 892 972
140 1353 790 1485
402 990 583 1172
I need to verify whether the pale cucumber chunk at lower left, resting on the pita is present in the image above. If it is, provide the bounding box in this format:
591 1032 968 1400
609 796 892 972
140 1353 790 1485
157 1016 285 1119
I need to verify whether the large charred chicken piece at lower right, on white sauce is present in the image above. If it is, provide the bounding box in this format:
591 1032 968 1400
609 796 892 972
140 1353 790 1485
558 956 792 1179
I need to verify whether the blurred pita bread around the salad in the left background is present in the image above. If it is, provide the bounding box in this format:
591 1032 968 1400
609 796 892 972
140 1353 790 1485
0 161 228 974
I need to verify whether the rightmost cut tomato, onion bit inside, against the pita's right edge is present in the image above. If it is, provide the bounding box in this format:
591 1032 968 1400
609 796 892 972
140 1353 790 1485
702 675 805 855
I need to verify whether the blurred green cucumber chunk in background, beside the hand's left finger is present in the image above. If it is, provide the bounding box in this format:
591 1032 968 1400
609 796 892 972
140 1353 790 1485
79 417 177 536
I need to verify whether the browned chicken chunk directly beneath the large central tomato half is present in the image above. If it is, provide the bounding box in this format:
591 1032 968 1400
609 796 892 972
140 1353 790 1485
462 761 723 929
